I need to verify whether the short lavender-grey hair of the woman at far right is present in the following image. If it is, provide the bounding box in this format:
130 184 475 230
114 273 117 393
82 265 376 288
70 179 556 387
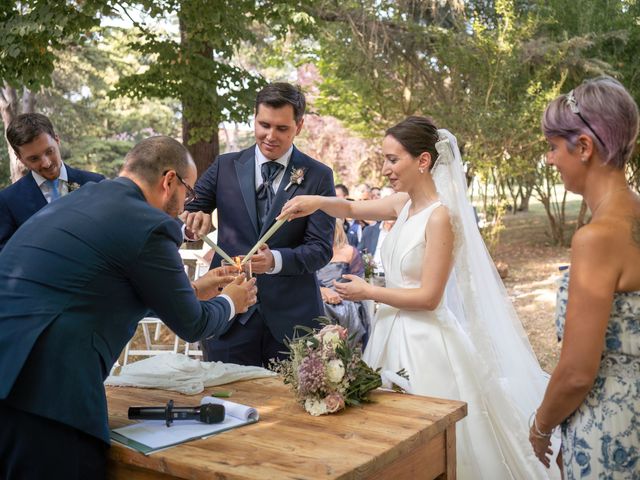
542 76 638 168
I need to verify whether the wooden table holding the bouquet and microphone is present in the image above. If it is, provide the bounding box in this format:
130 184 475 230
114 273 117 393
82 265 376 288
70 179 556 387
107 378 467 480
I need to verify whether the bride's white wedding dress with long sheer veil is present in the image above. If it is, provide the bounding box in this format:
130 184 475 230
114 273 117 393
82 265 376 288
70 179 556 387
364 128 559 480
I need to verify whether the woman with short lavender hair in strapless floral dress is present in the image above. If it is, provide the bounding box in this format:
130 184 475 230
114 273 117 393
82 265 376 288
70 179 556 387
529 77 640 480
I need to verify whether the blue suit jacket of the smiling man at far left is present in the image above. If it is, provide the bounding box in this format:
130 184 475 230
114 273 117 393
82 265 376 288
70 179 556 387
0 163 104 250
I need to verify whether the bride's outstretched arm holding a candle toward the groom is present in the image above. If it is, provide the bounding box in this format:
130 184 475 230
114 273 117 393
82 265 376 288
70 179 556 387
278 193 409 220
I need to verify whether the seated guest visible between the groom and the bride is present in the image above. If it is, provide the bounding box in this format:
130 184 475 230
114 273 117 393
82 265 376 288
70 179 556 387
317 219 371 348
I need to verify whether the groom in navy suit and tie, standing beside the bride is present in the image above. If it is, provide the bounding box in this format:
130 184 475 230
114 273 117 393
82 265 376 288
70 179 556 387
183 83 335 366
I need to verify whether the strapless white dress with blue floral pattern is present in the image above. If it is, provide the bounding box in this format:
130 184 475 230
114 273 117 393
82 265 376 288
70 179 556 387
556 271 640 480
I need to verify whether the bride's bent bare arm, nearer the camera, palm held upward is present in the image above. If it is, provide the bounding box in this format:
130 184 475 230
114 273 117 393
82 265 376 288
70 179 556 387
336 208 454 310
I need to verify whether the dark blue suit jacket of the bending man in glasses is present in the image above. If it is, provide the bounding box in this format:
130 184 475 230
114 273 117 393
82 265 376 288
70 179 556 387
0 177 232 442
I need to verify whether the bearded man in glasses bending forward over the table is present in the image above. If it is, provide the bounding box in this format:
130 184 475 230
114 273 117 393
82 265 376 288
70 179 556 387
0 137 257 480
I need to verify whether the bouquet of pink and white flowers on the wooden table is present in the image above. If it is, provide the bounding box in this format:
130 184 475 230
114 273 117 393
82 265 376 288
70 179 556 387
274 317 407 416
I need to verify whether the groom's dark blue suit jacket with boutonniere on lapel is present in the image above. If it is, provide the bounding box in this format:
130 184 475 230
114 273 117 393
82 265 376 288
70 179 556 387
187 146 335 342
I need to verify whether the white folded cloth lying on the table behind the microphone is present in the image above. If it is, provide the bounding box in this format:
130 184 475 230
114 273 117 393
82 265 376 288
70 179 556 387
104 353 275 395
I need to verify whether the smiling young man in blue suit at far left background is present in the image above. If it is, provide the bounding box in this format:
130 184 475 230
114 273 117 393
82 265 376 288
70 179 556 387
0 113 104 250
